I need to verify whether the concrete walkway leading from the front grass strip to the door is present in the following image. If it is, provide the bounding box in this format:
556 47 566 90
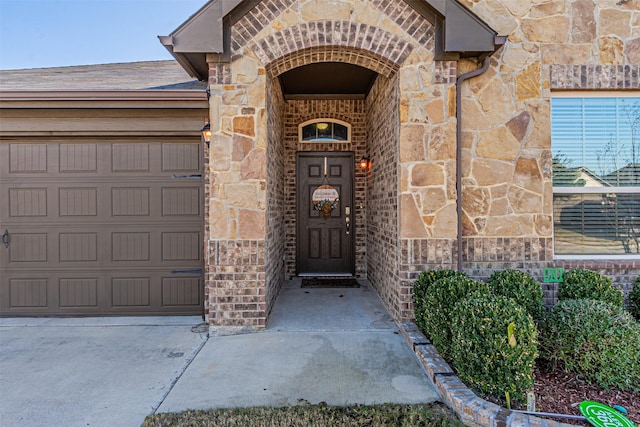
158 281 438 412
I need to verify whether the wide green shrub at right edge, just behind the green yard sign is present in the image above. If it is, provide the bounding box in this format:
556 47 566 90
540 299 640 391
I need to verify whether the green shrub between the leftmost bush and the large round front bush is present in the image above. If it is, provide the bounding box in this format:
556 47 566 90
422 276 491 359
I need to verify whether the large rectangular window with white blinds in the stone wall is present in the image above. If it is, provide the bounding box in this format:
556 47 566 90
551 96 640 258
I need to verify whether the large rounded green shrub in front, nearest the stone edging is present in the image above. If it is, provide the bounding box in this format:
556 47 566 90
451 294 538 402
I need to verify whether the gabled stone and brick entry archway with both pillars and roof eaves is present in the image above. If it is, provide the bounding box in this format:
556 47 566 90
161 0 505 328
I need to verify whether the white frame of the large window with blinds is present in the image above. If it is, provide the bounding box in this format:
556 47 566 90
549 90 640 261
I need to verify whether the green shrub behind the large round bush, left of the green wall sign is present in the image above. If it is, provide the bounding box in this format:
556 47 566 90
488 270 544 322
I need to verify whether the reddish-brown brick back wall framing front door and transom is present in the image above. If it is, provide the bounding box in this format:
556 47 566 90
283 100 367 277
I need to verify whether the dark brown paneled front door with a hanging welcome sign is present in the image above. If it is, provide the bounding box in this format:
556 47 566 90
297 152 355 276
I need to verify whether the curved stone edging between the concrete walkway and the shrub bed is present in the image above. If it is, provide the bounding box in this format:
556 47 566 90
400 322 575 427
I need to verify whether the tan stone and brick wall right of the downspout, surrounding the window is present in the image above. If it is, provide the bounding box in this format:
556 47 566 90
400 0 640 318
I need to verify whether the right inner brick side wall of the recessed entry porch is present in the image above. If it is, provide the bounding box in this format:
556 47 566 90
366 76 401 319
